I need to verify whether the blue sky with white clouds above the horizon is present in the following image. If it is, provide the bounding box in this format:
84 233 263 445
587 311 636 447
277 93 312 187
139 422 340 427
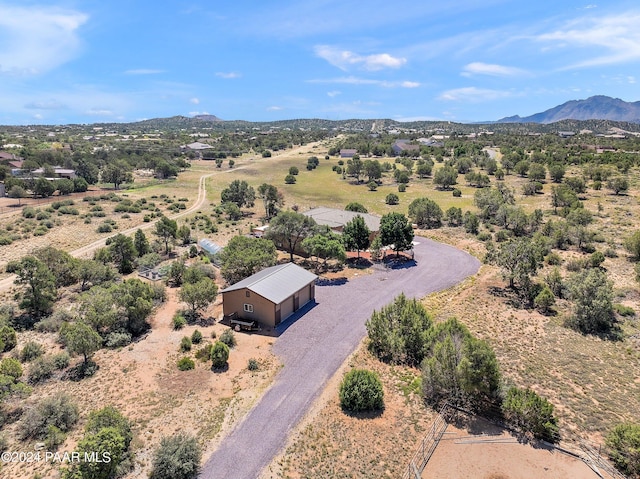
0 0 640 124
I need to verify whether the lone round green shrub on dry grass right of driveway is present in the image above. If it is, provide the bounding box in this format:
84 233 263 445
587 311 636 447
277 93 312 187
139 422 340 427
340 369 384 412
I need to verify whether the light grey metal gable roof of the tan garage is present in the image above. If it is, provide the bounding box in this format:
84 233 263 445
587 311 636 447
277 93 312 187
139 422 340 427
221 263 318 304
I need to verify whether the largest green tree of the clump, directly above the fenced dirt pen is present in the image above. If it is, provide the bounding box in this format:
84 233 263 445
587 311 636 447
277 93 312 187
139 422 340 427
422 318 500 407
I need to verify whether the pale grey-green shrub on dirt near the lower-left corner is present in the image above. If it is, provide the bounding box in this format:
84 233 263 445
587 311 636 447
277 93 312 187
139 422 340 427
18 394 79 440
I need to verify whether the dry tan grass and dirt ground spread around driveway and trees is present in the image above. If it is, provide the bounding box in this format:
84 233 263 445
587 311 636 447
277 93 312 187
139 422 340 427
0 143 640 479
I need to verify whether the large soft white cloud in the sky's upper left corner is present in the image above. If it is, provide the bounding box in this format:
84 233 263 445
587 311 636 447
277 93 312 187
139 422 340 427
0 4 89 75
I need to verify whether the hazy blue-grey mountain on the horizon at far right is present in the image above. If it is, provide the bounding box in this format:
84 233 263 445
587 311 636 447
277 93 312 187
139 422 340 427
496 95 640 123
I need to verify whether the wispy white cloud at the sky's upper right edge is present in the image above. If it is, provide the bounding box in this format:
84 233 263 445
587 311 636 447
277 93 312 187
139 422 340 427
534 11 640 70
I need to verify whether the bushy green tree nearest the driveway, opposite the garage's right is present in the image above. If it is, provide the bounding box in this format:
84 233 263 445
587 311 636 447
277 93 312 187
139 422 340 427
366 294 433 365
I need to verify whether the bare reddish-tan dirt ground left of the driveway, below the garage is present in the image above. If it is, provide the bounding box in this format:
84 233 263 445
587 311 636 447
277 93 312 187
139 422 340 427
2 289 279 479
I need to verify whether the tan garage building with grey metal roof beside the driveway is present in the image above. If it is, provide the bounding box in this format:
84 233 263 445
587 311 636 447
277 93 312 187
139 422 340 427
221 263 318 327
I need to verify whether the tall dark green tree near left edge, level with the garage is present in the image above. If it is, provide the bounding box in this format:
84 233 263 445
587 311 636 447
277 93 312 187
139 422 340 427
7 256 57 318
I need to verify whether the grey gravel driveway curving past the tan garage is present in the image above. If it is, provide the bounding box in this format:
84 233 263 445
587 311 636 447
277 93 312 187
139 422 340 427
200 237 480 479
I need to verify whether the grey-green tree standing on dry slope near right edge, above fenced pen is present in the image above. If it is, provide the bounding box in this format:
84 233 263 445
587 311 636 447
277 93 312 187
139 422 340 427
567 268 616 334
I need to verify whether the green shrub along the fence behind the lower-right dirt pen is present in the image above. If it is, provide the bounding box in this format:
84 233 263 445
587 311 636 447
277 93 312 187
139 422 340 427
502 387 559 442
